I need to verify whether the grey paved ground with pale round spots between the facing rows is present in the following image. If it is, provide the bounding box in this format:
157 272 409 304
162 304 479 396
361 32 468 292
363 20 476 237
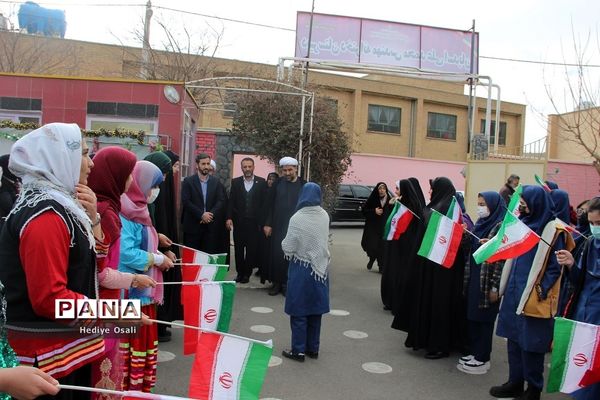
155 225 568 400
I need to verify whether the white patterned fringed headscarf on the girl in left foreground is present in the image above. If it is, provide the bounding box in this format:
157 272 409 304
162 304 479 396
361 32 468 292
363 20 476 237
9 123 95 247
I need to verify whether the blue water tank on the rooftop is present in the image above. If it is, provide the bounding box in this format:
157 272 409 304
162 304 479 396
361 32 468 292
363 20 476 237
18 1 67 38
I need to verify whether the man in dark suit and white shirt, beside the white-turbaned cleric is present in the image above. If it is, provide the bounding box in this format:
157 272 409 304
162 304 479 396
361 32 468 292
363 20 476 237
225 157 267 283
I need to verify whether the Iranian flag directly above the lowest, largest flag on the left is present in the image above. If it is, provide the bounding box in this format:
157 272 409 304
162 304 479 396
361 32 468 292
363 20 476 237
181 282 235 355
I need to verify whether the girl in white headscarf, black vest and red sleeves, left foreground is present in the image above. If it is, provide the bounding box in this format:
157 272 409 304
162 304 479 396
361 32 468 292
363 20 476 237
0 123 104 399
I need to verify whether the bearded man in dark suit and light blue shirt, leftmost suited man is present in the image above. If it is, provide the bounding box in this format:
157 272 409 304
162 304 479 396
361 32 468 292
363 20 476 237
181 153 226 253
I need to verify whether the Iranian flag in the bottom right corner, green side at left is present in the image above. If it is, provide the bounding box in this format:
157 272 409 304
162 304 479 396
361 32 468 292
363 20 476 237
547 318 600 393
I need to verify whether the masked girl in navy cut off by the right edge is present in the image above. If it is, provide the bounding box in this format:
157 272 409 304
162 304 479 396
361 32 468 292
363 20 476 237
556 197 600 400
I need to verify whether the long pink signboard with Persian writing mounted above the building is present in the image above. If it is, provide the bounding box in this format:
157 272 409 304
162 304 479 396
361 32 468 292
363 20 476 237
296 12 479 73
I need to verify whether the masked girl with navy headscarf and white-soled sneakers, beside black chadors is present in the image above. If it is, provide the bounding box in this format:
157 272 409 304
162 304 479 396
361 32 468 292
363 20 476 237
457 191 506 375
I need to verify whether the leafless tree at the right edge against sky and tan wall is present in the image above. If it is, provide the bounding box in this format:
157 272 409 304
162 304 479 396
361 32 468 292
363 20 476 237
545 29 600 174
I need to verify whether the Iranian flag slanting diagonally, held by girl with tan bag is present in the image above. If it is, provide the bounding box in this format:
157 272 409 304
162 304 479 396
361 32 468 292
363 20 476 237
473 186 540 264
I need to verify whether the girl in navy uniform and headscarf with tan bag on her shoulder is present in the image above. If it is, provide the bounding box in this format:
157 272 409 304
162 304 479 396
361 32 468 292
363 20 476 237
490 186 574 400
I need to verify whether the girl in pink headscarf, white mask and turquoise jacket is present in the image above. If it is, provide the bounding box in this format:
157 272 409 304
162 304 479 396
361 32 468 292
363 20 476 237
119 161 173 392
